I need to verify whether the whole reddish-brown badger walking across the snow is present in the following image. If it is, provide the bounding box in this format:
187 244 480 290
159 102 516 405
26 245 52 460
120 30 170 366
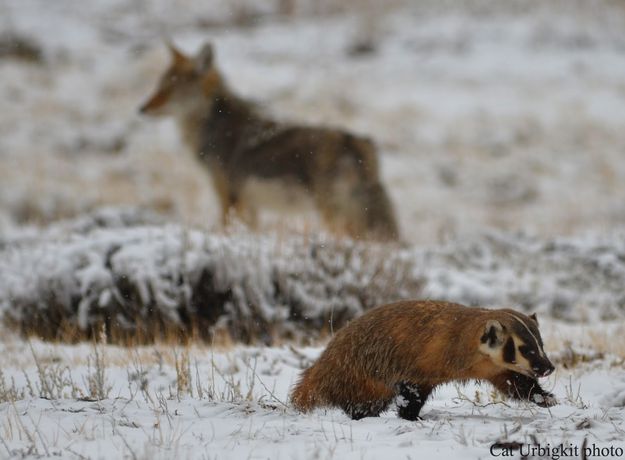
291 301 556 420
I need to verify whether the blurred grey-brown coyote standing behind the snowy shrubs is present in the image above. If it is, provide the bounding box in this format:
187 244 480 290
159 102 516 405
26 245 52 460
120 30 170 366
140 43 398 240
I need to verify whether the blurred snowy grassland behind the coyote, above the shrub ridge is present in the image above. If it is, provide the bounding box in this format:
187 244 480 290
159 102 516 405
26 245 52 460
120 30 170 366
0 0 625 244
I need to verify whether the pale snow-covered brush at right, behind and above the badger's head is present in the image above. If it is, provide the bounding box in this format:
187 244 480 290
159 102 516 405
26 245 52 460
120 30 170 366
412 232 625 321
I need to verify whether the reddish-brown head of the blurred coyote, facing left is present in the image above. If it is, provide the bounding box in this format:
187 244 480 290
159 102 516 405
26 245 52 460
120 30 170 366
139 43 222 116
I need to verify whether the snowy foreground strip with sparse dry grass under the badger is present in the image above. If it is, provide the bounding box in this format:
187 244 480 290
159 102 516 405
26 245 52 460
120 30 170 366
0 321 625 459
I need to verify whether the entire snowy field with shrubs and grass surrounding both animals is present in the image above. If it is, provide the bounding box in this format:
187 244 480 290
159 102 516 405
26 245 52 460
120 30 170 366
0 0 625 460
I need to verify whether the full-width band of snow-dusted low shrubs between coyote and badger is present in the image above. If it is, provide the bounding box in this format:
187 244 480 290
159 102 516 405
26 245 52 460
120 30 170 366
0 211 625 343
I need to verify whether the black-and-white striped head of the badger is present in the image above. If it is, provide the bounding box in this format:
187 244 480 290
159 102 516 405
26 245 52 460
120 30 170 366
480 309 554 378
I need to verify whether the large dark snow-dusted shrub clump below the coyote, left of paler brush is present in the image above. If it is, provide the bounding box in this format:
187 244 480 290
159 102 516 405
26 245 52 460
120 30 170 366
0 211 421 342
